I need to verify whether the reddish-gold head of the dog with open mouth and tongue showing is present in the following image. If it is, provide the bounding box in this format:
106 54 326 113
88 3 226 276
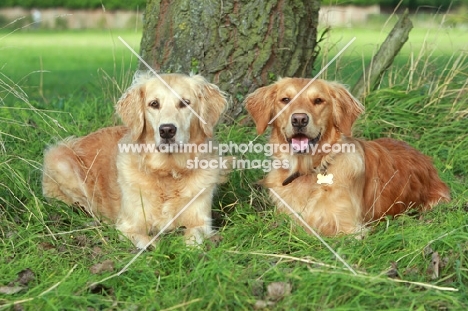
245 78 364 152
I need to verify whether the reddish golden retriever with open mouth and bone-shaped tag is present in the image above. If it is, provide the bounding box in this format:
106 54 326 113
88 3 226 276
245 78 450 236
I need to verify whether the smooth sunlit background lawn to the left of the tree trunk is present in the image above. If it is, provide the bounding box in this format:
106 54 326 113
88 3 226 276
0 30 141 103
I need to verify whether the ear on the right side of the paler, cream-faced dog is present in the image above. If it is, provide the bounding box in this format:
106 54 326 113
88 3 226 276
192 75 227 137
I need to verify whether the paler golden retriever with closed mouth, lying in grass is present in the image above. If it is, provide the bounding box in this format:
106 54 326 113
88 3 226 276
43 73 226 248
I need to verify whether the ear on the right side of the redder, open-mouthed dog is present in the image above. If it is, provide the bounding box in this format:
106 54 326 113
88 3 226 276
330 82 364 136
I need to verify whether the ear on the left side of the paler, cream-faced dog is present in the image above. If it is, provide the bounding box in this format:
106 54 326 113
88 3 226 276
115 84 145 141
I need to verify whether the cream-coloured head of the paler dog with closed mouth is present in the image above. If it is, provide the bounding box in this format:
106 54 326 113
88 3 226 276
116 73 227 146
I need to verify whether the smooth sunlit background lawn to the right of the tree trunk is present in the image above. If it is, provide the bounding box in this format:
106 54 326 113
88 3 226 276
318 19 468 86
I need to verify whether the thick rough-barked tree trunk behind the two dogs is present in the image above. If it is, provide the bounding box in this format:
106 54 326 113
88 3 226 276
140 0 320 123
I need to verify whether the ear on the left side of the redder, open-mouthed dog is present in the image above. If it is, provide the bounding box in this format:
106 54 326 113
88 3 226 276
244 84 276 135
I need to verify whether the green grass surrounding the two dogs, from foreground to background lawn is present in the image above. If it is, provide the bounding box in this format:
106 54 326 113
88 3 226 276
0 20 468 310
